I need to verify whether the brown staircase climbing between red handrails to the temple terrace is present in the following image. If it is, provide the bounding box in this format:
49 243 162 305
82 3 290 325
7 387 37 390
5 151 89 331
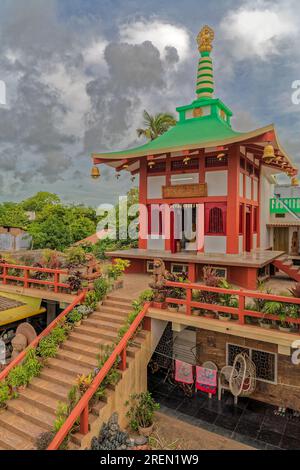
0 295 145 450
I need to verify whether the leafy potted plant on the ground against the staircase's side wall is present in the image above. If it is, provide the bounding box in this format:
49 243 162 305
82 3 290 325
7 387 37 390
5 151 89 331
125 391 160 437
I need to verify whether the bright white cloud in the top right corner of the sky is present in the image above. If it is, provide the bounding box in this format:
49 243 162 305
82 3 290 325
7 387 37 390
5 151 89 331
221 7 298 59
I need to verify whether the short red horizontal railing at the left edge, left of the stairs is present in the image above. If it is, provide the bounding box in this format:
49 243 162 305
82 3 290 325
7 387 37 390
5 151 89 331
0 263 69 293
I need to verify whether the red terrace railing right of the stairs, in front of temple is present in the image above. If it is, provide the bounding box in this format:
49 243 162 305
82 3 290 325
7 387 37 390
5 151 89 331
166 281 300 325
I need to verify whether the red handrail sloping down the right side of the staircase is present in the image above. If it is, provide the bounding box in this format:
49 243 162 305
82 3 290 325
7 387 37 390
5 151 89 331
47 302 150 450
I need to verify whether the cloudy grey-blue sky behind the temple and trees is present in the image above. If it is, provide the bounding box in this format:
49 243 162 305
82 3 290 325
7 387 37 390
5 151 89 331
0 0 300 206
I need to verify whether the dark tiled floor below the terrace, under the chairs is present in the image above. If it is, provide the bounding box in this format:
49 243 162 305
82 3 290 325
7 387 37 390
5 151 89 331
148 372 300 450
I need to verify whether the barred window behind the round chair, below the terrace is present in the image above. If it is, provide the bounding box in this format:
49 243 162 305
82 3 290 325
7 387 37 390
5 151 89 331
226 343 277 384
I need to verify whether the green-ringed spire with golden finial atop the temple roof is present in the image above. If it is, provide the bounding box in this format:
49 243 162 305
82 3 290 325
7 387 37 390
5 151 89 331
196 26 215 99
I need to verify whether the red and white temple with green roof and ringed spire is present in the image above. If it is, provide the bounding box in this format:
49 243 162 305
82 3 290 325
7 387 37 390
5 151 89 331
93 26 297 289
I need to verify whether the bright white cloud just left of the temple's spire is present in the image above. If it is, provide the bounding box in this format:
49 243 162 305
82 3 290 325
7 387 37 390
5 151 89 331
120 20 190 60
